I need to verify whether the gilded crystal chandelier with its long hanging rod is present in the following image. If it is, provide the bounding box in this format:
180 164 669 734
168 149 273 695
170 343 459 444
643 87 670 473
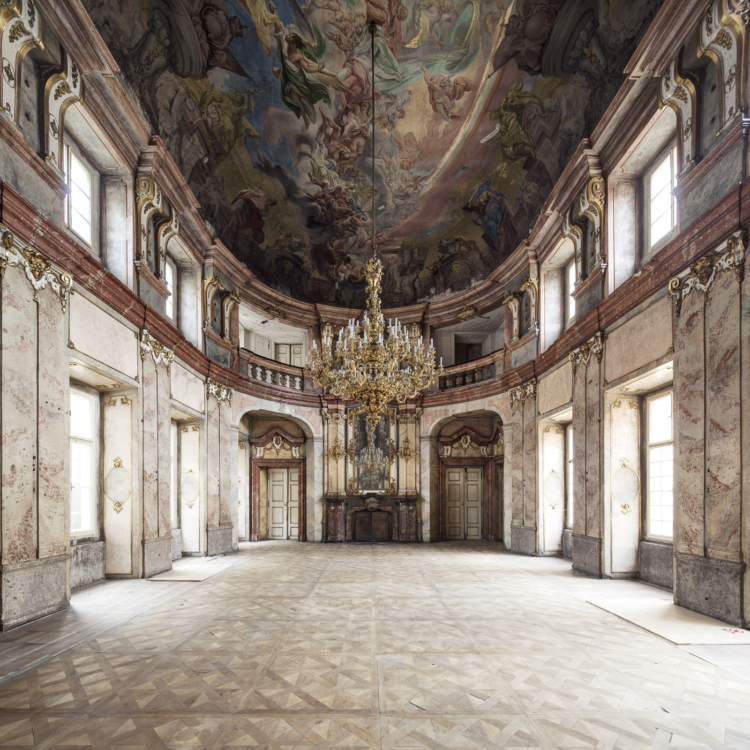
309 22 443 424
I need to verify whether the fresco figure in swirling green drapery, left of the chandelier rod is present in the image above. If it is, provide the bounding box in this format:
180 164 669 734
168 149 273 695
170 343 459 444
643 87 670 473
269 8 345 128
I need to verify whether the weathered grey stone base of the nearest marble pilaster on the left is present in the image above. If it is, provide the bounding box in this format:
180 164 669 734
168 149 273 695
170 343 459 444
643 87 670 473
0 555 70 630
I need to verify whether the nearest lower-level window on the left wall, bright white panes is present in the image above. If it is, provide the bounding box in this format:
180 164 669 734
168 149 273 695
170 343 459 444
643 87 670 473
70 388 96 536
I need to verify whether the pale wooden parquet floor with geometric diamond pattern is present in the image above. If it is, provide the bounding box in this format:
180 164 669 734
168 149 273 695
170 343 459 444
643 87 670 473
0 542 750 750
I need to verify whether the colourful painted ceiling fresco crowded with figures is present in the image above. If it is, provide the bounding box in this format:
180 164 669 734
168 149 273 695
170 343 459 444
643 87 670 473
84 0 660 307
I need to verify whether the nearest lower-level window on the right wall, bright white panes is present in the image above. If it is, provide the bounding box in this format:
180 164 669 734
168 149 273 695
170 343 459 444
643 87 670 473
646 391 674 539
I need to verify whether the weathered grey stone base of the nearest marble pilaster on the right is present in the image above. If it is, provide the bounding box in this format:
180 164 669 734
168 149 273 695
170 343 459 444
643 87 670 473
674 552 748 628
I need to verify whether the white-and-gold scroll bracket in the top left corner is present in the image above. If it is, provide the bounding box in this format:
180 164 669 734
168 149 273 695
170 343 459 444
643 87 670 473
0 0 44 123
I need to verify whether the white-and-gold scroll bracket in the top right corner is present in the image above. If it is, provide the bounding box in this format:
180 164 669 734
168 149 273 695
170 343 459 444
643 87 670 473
696 0 750 135
